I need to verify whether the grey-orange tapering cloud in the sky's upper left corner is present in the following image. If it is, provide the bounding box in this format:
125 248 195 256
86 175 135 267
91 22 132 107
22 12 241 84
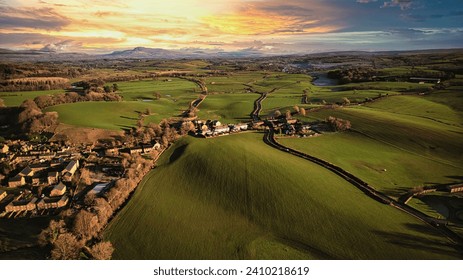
0 6 71 30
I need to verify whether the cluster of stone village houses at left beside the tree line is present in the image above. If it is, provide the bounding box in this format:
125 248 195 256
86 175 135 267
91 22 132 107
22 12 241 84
0 140 161 218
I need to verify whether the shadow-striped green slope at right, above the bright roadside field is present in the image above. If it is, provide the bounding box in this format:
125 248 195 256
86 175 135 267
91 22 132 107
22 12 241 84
300 97 463 166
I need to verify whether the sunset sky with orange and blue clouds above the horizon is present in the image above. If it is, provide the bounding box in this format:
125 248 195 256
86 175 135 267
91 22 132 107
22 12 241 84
0 0 463 54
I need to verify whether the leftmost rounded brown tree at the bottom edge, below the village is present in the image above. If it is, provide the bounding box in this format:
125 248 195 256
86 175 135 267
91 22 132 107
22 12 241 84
51 233 82 260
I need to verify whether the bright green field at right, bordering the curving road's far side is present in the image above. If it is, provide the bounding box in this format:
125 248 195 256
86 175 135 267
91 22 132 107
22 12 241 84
279 133 463 197
